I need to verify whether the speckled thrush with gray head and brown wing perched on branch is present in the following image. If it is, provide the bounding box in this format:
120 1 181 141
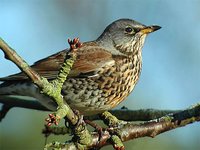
0 18 161 116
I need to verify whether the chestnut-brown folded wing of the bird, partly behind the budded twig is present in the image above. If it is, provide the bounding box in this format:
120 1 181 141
0 43 115 81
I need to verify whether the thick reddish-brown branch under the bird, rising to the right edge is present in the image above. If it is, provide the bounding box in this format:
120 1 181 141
45 104 200 150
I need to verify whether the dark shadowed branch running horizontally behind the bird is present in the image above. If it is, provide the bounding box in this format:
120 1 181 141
0 96 181 121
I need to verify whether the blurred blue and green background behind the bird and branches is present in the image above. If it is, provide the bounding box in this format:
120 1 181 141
0 0 200 150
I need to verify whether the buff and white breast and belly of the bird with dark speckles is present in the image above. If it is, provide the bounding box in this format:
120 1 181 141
62 56 141 115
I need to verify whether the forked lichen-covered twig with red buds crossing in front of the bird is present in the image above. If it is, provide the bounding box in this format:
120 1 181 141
0 38 92 147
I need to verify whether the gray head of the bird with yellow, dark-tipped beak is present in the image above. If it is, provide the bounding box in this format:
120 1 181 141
97 19 161 54
